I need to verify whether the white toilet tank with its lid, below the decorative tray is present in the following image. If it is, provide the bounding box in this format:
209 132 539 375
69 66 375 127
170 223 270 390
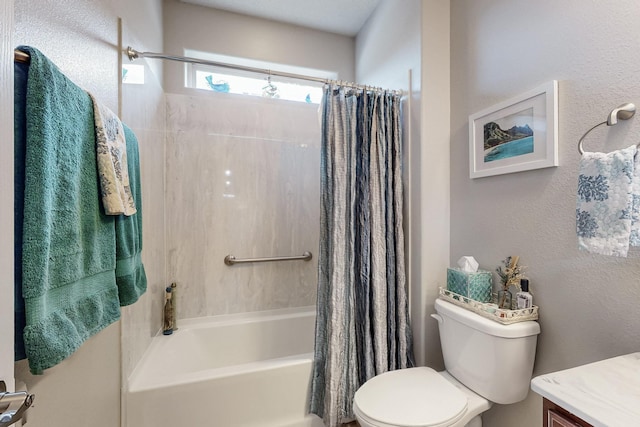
432 299 540 404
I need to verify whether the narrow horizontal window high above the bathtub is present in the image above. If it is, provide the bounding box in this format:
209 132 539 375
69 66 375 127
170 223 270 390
185 52 336 104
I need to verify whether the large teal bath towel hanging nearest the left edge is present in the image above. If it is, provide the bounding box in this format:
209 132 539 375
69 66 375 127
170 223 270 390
20 46 120 374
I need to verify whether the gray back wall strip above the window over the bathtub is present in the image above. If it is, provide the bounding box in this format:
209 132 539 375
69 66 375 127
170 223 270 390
164 0 354 93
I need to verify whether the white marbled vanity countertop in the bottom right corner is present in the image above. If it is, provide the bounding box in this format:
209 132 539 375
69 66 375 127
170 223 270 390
531 352 640 427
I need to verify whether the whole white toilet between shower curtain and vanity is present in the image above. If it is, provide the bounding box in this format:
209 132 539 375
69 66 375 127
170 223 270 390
353 299 540 427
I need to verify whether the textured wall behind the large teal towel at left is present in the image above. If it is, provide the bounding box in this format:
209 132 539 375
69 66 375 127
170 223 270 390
15 4 120 427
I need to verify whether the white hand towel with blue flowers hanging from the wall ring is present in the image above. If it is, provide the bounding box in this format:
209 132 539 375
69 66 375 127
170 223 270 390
576 145 640 257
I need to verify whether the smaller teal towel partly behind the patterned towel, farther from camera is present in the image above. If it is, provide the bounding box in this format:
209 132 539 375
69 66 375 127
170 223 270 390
116 123 147 306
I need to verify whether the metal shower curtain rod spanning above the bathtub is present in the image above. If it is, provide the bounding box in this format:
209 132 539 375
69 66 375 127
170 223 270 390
125 46 402 95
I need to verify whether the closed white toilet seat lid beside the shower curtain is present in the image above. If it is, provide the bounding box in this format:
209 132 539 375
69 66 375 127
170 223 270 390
353 367 468 427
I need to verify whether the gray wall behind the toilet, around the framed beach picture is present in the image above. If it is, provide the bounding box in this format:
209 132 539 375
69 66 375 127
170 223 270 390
452 0 640 427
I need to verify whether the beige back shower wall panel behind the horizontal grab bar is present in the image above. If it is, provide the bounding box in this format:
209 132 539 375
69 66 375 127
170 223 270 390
165 92 320 319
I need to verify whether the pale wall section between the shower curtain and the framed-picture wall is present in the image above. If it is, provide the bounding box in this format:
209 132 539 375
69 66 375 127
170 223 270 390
356 0 449 368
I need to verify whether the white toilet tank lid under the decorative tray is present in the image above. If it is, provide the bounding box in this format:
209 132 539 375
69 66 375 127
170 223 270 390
435 298 540 338
